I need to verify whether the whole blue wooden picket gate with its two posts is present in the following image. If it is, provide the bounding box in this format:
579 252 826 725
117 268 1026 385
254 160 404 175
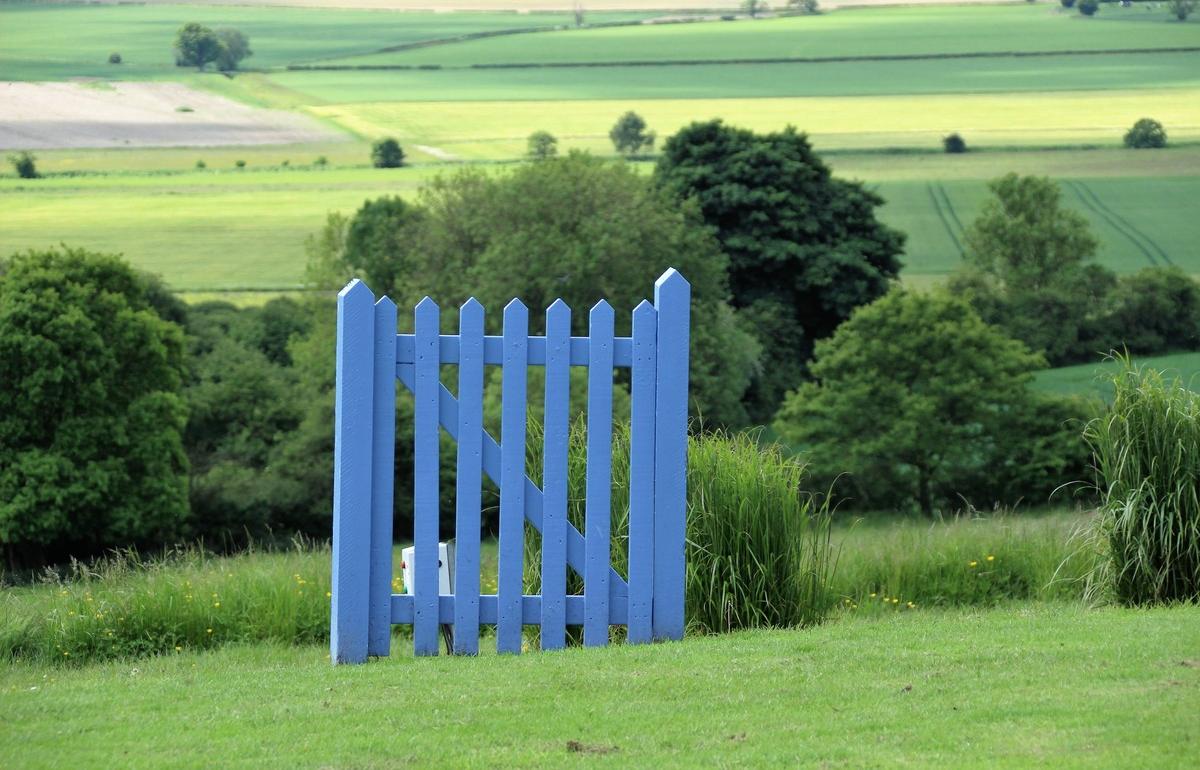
330 270 691 663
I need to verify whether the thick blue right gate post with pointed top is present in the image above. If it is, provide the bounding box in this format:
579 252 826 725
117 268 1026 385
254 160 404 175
652 267 691 639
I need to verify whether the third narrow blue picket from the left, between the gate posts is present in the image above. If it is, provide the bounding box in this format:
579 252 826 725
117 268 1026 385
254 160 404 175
454 297 484 655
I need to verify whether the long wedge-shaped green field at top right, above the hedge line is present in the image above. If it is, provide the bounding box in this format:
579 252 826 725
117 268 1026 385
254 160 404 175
328 4 1200 66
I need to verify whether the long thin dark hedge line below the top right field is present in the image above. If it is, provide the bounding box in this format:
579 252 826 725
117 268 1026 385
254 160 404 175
287 46 1200 71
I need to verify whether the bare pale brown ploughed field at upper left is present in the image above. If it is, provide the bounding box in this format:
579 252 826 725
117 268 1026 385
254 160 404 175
0 83 342 150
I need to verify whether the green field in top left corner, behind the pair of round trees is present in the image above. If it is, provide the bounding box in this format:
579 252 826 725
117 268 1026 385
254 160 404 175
0 4 638 80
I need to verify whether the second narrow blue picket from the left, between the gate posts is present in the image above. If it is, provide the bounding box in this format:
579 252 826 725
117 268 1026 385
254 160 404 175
413 297 442 655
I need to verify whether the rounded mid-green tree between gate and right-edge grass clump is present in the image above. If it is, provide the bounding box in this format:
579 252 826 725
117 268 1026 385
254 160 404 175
775 289 1043 515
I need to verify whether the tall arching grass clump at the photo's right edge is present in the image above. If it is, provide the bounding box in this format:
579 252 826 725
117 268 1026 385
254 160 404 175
1085 356 1200 604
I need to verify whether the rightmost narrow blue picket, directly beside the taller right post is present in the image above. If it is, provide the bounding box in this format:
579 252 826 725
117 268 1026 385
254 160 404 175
628 301 658 644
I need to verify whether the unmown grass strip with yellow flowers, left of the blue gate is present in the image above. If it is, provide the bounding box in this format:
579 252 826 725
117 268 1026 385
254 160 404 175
0 543 330 664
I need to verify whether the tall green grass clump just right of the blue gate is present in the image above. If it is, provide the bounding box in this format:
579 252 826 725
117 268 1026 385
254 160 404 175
686 432 833 632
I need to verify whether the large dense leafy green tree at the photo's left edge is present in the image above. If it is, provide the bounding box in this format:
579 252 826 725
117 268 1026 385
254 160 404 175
0 247 187 564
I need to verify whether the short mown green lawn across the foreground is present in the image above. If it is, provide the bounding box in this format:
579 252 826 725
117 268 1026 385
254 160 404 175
0 604 1200 768
